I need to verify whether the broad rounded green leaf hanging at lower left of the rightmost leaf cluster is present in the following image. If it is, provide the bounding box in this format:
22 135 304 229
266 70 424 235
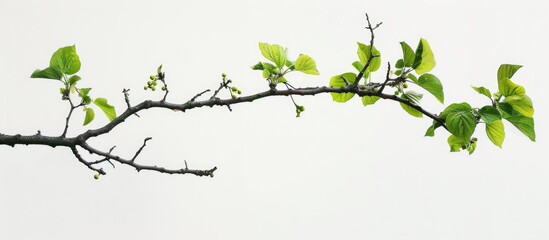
441 103 477 140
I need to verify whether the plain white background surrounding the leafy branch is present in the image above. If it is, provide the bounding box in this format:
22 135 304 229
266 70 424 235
0 0 549 240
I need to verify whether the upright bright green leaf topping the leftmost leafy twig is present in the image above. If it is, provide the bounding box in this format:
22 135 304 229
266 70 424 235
50 45 80 75
